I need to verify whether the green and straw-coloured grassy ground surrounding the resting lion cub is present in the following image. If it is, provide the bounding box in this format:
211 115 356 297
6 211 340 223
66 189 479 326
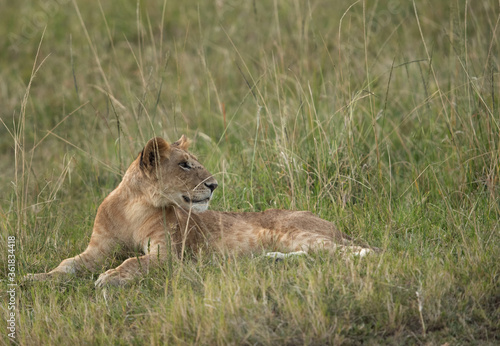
0 0 500 345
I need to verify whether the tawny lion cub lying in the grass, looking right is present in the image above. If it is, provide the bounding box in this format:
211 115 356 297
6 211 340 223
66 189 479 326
28 136 372 287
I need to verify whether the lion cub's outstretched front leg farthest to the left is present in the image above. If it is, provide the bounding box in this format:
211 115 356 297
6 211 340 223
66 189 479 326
25 226 118 281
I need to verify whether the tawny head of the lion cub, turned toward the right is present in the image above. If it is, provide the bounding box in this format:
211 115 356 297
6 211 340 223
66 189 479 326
123 135 217 212
